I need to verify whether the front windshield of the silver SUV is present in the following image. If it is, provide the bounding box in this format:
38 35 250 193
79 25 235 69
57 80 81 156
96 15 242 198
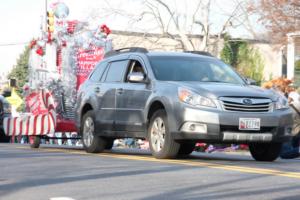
150 56 245 84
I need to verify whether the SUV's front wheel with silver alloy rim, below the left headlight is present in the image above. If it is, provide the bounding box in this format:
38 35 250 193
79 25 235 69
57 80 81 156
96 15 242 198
148 110 180 159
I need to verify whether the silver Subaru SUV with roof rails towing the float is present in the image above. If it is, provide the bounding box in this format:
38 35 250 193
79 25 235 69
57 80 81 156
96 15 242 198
76 48 292 161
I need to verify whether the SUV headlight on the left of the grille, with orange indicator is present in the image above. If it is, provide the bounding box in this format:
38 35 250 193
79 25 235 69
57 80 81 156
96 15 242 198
178 88 217 108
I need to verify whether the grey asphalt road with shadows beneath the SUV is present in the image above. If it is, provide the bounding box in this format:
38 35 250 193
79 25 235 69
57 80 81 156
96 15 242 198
0 144 300 200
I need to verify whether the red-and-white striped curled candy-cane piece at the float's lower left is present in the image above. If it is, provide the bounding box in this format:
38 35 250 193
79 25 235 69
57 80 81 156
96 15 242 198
3 90 56 137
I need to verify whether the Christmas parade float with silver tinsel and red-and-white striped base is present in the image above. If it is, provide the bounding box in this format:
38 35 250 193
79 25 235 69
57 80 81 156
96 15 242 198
3 2 112 147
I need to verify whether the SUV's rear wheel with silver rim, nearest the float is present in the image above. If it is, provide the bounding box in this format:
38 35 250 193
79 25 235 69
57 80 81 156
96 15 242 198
80 110 106 153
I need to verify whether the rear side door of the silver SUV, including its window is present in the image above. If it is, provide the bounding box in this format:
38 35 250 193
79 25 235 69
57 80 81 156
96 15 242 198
95 60 128 131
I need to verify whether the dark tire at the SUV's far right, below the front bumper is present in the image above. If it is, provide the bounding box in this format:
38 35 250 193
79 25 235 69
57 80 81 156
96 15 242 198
249 143 282 162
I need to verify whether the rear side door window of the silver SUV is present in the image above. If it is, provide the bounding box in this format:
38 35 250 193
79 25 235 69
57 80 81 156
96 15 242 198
105 60 128 82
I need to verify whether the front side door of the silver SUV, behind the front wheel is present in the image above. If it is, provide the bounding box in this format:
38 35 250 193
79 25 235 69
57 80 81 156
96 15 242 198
115 56 151 132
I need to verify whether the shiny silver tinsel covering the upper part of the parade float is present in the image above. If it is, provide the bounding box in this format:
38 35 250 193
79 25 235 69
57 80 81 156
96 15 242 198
25 4 112 118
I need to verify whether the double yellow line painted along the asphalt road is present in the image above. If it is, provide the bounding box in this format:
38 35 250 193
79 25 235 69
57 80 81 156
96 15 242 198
16 147 300 179
